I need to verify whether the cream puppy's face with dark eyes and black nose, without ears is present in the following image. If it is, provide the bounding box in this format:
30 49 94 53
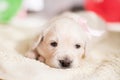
36 18 87 68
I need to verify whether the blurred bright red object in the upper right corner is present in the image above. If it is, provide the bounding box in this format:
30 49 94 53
85 0 120 22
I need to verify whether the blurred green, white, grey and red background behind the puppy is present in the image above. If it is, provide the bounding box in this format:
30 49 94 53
0 0 120 31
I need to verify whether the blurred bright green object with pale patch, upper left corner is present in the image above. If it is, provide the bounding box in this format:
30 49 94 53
0 0 22 23
